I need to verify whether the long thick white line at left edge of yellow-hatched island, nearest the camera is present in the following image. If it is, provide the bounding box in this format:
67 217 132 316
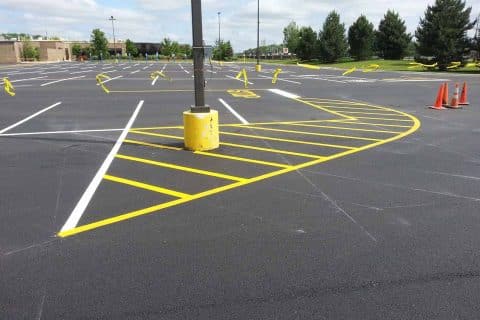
60 100 144 232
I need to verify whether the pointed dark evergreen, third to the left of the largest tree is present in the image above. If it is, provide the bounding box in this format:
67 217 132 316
318 11 348 62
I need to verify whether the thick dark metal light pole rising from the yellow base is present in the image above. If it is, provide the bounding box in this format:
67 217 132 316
191 0 210 112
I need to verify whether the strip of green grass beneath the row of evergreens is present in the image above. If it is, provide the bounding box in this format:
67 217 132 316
247 59 480 73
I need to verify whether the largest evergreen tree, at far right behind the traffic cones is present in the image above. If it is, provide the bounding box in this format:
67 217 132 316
415 0 475 70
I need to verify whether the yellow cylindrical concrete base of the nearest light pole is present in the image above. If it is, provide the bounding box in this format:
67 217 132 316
183 109 220 151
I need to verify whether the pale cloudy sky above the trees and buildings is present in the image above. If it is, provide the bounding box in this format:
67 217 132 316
0 0 480 52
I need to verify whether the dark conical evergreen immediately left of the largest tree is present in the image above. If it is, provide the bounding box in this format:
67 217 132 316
375 10 412 59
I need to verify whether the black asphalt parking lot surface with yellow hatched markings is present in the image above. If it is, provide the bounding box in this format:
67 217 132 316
0 61 480 319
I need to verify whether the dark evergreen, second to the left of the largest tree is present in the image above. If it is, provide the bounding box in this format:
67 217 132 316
348 14 375 60
